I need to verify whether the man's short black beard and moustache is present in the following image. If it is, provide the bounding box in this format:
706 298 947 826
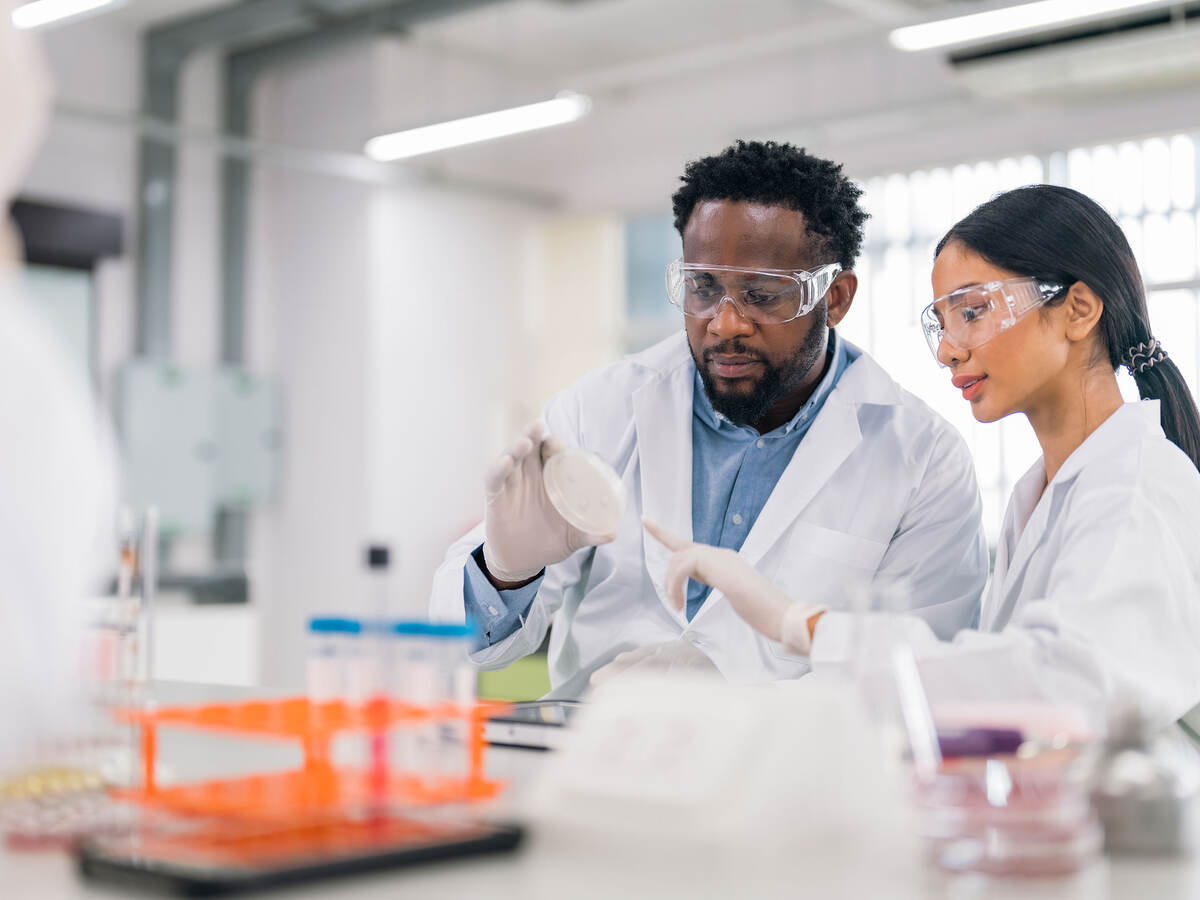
688 304 828 426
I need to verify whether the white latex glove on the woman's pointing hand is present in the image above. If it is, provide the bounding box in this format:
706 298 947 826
642 518 829 655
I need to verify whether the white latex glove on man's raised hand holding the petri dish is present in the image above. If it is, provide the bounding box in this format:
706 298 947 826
484 421 617 582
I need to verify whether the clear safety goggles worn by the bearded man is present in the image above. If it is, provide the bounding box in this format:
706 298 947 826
667 258 841 325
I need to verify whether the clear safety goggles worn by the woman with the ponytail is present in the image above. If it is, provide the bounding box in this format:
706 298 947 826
920 276 1066 365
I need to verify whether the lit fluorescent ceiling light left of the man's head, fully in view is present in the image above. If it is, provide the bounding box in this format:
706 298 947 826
365 91 592 162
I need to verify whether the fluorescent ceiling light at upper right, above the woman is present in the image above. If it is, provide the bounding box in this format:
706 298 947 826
888 0 1164 50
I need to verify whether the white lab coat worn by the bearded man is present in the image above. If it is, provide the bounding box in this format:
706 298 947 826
431 332 988 696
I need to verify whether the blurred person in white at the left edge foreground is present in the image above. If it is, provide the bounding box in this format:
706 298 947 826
0 2 113 832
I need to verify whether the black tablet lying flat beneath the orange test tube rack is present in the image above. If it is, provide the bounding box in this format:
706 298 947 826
77 816 522 896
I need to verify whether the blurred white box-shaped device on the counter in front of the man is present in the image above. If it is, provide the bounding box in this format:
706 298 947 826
526 673 920 896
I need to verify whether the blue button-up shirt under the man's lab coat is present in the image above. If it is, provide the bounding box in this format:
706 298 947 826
463 330 858 647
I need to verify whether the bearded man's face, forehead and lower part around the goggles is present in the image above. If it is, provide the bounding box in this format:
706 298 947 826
683 200 829 427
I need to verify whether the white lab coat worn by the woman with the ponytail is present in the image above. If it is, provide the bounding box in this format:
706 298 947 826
812 401 1200 748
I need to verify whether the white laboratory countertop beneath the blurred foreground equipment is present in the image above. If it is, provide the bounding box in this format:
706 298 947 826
0 685 1200 900
